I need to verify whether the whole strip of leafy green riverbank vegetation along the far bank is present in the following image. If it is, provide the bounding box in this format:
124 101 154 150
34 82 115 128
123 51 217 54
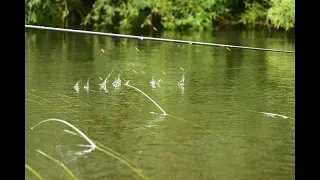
25 0 295 31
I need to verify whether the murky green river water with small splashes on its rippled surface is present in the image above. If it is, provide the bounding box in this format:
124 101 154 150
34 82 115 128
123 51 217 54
25 31 295 180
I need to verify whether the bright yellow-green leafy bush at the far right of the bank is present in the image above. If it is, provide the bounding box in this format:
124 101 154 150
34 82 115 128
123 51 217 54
267 0 295 30
